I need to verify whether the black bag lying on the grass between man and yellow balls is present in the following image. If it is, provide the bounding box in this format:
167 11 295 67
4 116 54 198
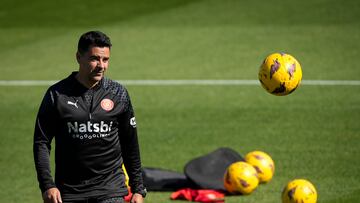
142 148 244 191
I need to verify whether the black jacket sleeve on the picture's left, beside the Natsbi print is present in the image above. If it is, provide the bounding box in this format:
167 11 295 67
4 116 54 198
33 90 56 193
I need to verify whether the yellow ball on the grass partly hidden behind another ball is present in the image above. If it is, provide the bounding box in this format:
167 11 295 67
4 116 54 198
245 151 275 183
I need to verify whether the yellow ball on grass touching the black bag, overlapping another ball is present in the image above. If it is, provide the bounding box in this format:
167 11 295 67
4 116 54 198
224 161 259 195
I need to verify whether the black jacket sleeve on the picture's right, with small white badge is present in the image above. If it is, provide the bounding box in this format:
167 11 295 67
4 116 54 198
118 91 145 194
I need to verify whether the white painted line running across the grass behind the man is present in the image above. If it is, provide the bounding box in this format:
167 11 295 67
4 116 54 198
0 80 360 86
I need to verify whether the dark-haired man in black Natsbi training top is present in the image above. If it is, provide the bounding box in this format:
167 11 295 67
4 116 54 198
33 31 146 203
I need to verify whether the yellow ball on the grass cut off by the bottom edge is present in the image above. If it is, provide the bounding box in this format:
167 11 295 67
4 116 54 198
282 179 317 203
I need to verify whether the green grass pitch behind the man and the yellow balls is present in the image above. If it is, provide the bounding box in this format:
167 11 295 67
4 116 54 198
0 0 360 203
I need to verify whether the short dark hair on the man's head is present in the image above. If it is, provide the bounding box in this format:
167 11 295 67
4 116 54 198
78 31 112 54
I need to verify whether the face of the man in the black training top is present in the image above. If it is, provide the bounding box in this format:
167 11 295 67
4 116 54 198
76 46 110 84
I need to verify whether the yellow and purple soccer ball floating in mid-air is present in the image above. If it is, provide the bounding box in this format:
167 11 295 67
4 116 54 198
259 53 302 96
